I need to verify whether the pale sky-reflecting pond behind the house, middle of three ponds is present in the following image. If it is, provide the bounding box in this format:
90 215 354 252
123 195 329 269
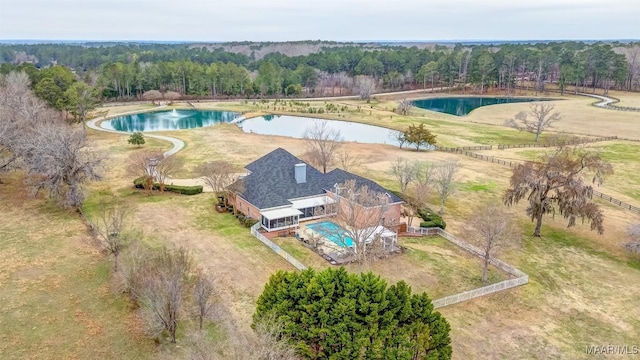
238 115 398 145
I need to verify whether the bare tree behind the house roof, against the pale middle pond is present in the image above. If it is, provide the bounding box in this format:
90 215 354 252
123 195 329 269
303 120 342 173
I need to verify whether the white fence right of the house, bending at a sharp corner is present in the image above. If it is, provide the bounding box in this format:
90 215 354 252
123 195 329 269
407 227 529 308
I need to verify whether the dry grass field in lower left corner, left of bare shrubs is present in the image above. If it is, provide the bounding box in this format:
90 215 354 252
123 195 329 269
0 173 153 359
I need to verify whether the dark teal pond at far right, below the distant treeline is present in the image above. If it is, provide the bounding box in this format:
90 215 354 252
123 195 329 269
413 97 551 116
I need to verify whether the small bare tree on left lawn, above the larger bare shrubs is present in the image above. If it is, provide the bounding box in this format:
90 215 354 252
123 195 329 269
91 202 140 272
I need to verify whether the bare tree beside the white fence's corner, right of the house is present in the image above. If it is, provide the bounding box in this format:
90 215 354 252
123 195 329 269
465 205 520 282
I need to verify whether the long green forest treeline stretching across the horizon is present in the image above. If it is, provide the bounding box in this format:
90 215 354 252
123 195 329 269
0 42 640 99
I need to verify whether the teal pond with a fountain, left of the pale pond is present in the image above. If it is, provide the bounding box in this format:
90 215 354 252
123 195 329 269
100 109 240 132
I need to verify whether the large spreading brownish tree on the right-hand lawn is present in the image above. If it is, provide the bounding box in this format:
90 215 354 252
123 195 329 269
504 148 613 236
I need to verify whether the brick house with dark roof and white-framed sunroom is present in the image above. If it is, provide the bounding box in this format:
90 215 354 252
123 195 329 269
232 148 402 232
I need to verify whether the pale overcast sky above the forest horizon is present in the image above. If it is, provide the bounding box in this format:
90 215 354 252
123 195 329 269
0 0 640 41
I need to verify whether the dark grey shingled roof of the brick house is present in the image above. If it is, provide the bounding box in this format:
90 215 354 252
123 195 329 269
242 148 402 209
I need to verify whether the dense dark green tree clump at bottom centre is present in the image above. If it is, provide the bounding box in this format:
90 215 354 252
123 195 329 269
254 268 452 360
